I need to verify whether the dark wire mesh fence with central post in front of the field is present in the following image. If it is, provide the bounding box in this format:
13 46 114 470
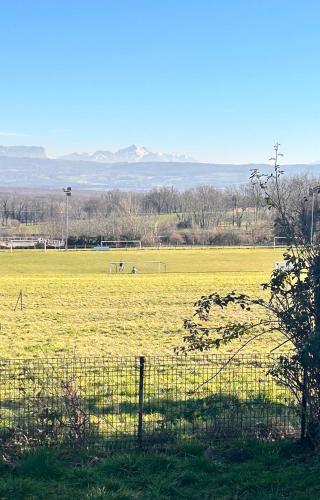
0 355 299 448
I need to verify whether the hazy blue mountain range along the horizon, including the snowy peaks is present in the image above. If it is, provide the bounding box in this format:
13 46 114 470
0 146 320 191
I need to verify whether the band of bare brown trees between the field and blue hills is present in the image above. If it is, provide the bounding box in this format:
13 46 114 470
0 175 320 247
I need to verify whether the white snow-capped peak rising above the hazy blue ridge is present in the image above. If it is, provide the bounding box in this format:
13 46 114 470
60 144 194 163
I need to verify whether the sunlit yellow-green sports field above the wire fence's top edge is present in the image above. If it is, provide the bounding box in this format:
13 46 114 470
0 249 282 358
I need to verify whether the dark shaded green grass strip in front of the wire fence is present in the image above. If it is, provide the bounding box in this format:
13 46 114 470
0 442 320 500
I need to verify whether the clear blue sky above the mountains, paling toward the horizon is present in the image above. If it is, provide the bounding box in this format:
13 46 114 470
0 0 320 163
